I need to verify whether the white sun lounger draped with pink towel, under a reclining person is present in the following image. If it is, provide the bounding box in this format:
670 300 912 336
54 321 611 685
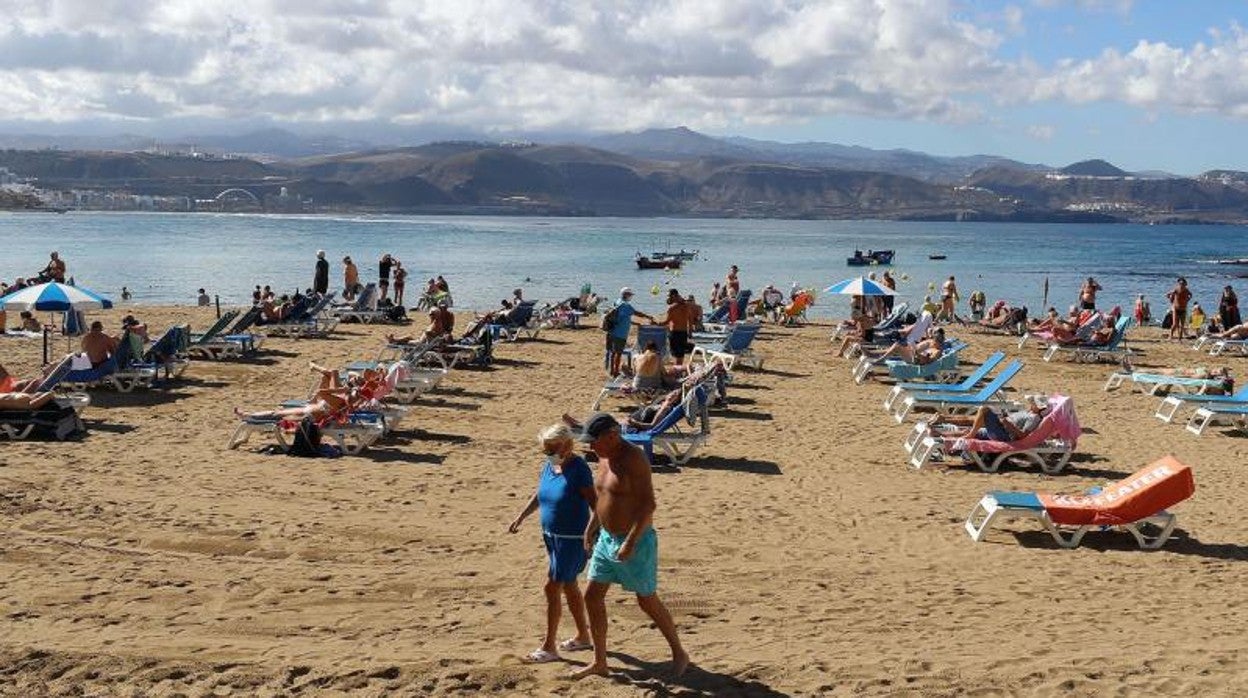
910 396 1082 474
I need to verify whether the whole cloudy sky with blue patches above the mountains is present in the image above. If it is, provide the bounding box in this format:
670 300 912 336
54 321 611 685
0 0 1248 174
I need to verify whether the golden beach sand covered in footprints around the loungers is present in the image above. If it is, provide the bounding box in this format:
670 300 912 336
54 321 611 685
0 307 1248 697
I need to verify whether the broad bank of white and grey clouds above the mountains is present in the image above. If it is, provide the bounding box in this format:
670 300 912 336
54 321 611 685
0 0 1248 131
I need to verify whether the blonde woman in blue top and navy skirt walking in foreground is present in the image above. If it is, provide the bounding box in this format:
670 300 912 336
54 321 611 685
507 425 598 663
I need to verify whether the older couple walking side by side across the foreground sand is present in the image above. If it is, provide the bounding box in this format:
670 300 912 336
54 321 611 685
508 412 689 679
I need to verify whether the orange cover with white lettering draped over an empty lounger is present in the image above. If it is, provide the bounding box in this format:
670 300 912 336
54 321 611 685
1038 456 1196 526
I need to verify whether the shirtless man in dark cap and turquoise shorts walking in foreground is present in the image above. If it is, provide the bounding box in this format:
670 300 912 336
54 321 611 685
573 412 689 678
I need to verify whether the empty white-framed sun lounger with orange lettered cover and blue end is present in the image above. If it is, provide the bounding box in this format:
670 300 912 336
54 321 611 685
965 456 1196 549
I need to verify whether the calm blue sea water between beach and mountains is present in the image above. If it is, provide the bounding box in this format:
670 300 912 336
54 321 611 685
0 212 1248 316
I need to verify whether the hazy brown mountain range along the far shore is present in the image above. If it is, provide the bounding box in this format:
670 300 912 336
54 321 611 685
0 127 1248 222
